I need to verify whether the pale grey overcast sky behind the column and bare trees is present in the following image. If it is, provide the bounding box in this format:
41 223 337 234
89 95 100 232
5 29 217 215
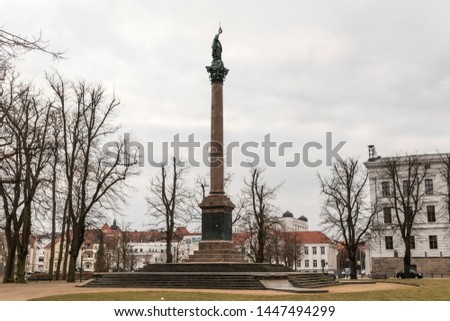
0 0 450 230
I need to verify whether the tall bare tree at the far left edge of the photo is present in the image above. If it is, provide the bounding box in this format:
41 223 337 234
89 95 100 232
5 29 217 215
0 76 50 282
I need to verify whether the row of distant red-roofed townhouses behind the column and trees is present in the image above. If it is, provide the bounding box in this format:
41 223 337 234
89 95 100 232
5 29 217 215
0 211 337 272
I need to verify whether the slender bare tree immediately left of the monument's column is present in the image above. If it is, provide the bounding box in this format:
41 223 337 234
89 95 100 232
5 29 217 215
146 158 191 263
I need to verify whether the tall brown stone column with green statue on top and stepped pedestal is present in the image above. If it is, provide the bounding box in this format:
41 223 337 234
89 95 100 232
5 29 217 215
189 28 246 262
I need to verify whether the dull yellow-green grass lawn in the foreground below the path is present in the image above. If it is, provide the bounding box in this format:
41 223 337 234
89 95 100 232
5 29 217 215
30 279 450 301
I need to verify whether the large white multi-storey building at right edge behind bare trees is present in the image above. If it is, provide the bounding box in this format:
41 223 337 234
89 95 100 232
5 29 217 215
364 146 450 276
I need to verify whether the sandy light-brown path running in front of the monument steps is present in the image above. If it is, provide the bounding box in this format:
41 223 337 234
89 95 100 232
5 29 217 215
0 281 405 301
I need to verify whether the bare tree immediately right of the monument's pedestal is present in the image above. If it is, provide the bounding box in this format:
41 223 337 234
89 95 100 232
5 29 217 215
242 167 281 263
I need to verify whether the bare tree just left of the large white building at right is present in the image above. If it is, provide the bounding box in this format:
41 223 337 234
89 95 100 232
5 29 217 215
319 158 376 279
